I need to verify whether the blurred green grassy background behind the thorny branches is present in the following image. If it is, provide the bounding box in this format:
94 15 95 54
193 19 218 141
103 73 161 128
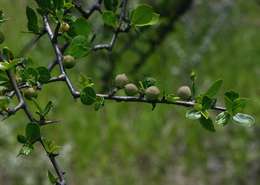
0 0 260 185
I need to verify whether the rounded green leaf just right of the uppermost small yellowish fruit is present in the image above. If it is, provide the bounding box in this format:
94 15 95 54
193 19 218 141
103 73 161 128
72 17 91 38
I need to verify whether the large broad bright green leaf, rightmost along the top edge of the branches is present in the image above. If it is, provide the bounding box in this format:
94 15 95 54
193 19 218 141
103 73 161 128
131 4 159 27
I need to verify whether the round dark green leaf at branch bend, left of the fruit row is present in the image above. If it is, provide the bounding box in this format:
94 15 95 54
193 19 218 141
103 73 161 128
80 87 96 105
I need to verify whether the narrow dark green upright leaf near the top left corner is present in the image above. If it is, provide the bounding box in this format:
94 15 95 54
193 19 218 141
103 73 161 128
26 6 39 33
